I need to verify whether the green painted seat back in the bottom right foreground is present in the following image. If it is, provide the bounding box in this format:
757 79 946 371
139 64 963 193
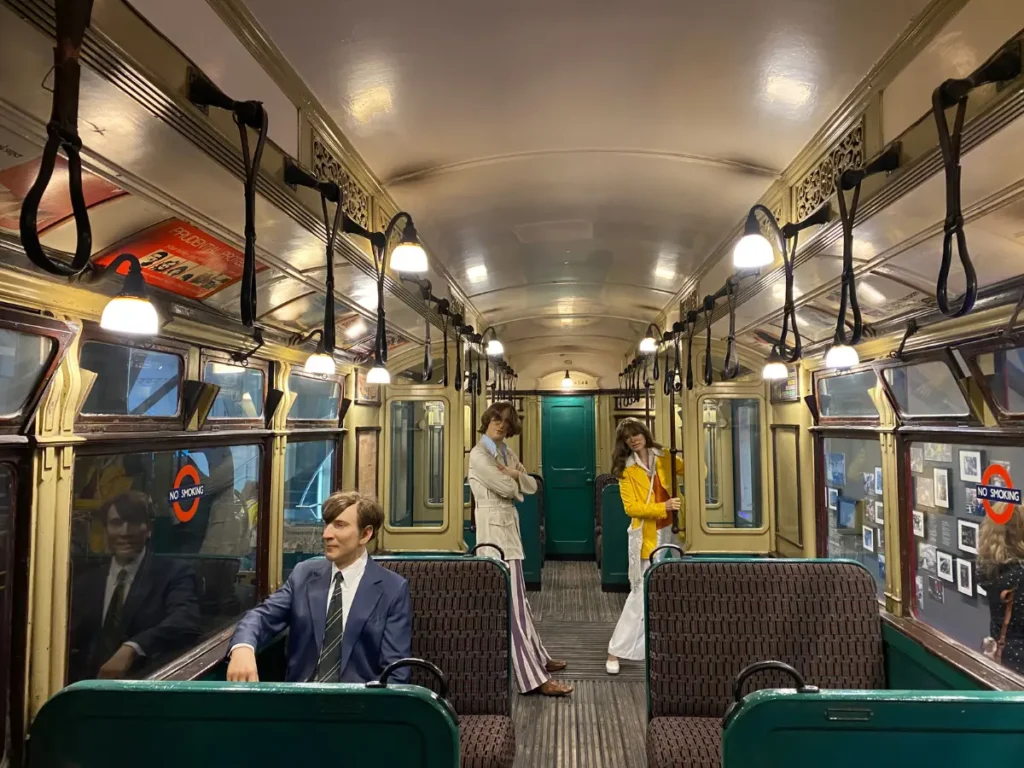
722 690 1024 768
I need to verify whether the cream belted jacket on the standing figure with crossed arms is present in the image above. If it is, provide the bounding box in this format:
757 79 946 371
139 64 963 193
469 442 537 560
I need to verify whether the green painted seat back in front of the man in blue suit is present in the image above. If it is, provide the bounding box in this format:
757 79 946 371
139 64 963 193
29 681 459 768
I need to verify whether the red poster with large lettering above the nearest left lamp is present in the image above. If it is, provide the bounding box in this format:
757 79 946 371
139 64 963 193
95 219 263 299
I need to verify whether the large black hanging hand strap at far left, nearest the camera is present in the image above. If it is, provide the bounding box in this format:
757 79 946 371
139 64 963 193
19 0 92 278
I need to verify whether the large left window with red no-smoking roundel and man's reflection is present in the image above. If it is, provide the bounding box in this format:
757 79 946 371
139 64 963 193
68 445 261 682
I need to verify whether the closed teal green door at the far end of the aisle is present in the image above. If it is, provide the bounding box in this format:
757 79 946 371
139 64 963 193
541 396 594 558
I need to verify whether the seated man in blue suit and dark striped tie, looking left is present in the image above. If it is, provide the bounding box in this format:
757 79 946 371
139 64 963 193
227 493 413 683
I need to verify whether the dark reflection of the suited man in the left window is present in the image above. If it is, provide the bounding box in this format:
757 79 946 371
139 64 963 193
69 490 200 682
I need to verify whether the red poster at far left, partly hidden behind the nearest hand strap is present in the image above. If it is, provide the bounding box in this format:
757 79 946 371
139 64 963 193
0 155 127 233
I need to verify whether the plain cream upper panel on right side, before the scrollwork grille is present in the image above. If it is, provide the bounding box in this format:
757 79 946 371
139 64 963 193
882 0 1024 143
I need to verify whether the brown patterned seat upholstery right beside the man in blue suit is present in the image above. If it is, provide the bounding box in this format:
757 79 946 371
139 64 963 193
378 557 515 768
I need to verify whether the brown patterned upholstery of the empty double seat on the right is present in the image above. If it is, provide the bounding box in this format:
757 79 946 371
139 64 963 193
646 558 886 768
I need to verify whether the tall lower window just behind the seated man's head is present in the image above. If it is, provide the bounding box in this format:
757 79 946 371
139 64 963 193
284 440 337 579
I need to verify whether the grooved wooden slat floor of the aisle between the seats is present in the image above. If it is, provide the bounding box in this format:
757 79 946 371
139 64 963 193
512 561 647 768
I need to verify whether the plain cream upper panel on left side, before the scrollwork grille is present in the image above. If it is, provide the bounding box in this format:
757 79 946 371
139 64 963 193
130 0 299 158
